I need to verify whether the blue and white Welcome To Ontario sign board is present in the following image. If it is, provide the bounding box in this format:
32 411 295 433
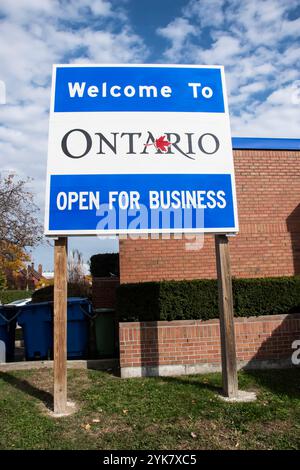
45 65 238 236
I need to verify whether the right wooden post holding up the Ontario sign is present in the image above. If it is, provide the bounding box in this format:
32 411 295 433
215 235 238 398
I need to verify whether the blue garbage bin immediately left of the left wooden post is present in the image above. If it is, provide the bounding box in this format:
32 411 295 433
18 302 53 361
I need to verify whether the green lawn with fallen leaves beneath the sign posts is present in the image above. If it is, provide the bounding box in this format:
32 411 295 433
0 368 300 450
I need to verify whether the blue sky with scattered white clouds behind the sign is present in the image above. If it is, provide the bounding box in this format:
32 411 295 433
0 0 300 269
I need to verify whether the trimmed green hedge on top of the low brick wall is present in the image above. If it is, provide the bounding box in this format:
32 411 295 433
117 276 300 321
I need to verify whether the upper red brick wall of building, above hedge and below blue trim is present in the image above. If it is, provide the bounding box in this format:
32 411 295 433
120 150 300 283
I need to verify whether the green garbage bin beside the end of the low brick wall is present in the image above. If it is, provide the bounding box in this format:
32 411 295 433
94 308 116 357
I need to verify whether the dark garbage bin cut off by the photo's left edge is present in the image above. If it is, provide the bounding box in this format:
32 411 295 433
0 305 19 362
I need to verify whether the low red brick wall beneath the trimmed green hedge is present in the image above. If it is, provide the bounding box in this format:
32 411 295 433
119 314 300 377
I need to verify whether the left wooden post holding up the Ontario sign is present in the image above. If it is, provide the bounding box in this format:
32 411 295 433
54 237 68 415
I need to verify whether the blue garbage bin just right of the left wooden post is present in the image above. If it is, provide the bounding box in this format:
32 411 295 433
67 297 92 359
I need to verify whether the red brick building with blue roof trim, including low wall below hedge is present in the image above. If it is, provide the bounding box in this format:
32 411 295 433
119 139 300 377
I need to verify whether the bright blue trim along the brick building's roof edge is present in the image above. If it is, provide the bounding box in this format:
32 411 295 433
232 137 300 150
